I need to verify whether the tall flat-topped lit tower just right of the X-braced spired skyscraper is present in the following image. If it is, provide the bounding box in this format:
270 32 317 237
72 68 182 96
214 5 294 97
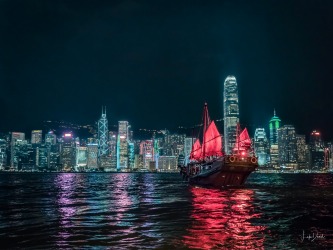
117 121 129 171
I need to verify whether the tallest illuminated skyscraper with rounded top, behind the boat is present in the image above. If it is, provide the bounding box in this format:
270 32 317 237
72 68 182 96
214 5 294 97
223 76 239 154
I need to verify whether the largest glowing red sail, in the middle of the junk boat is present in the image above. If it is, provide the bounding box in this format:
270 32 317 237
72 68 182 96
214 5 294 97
203 121 222 157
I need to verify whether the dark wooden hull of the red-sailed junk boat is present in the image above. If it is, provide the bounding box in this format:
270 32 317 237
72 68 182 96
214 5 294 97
184 158 258 188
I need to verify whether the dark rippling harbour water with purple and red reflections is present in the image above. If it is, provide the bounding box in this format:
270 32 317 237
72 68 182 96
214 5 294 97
0 173 333 249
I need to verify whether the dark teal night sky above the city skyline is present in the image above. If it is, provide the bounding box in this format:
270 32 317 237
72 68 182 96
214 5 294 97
0 0 333 140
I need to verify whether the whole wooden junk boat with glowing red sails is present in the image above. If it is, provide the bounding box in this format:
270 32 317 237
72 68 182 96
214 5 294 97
180 103 258 188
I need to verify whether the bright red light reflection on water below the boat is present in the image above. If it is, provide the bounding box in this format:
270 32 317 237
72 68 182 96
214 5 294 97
183 188 265 249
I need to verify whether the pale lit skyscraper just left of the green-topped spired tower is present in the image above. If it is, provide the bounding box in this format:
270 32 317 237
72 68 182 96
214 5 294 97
254 128 269 166
